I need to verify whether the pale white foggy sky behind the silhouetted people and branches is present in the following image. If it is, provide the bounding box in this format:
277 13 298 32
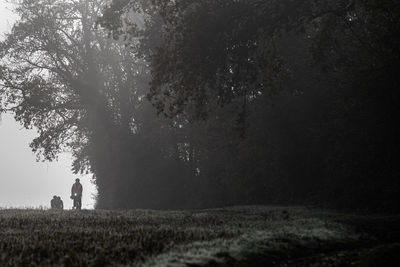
0 0 96 209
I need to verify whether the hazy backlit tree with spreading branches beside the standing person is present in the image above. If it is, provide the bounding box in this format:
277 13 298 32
0 0 170 207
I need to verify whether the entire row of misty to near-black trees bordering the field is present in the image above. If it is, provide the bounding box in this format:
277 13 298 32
0 0 400 211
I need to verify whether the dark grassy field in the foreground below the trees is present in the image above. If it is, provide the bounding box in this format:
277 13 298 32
0 206 400 266
